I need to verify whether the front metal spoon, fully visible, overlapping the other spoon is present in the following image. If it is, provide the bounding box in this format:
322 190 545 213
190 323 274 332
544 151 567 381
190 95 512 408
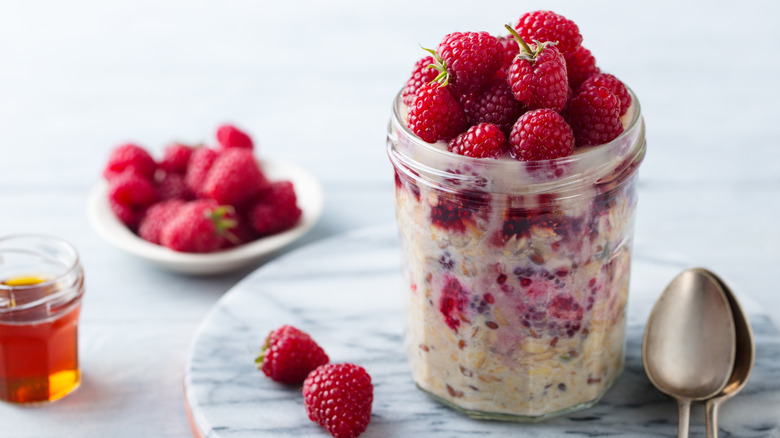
642 268 736 438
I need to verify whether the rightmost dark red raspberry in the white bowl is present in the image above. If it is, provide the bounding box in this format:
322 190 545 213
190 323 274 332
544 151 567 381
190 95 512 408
247 181 302 236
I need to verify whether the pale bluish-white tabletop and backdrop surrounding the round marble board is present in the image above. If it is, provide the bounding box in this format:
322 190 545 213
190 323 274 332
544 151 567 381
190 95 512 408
0 0 780 438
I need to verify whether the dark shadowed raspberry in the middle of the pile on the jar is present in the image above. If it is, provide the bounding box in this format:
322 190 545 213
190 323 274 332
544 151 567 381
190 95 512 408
461 77 525 135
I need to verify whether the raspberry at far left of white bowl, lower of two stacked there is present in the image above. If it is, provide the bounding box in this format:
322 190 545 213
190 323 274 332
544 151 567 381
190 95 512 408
108 169 160 230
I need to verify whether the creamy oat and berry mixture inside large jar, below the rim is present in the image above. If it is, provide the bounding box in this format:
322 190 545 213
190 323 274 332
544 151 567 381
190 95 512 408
396 171 635 417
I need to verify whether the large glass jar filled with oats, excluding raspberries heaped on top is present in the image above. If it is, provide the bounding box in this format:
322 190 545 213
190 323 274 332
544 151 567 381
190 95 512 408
387 93 645 421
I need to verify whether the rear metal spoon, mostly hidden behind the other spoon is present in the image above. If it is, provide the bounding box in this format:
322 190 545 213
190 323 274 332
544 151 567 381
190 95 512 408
705 271 756 438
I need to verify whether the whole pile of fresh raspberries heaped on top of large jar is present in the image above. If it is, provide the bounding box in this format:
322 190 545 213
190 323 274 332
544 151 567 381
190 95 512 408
402 11 631 161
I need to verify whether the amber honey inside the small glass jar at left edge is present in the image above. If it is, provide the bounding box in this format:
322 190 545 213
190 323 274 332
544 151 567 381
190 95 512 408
0 275 81 403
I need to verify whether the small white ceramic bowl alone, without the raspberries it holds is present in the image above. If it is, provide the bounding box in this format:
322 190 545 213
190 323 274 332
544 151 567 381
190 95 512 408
87 159 322 275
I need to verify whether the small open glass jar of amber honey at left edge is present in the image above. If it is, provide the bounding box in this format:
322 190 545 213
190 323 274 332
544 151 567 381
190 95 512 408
0 235 84 403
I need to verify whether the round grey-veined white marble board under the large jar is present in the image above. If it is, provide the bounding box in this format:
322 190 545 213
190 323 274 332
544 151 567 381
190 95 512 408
184 226 780 438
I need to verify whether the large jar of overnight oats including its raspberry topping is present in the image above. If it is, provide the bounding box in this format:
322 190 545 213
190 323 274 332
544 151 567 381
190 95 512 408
388 11 645 421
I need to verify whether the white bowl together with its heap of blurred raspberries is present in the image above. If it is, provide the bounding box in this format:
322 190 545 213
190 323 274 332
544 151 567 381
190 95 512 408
88 125 322 275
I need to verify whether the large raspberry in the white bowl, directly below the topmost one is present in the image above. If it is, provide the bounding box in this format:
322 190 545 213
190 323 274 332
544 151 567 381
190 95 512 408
202 148 268 206
